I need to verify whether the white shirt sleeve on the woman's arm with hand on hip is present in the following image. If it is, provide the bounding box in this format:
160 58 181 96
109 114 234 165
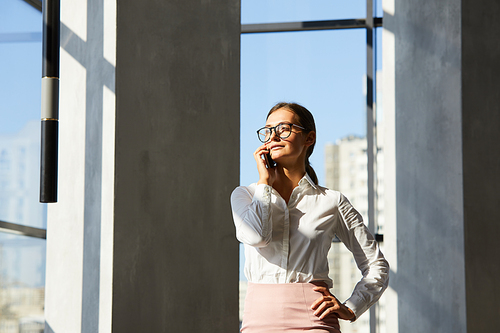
336 194 389 318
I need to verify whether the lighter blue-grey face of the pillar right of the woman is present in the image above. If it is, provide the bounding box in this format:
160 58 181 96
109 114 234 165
393 0 466 333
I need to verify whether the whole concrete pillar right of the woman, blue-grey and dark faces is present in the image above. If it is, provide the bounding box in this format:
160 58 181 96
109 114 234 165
384 0 500 333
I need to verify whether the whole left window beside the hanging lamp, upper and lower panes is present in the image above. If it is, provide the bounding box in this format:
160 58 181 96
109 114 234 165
0 0 46 332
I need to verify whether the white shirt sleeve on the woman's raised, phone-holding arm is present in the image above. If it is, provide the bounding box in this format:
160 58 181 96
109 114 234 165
231 184 272 247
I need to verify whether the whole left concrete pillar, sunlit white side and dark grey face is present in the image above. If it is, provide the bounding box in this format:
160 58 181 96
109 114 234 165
46 0 240 333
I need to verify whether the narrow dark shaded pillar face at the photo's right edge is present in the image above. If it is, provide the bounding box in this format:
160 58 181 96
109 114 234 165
462 0 500 333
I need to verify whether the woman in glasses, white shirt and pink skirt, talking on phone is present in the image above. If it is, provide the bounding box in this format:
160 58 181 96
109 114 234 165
231 103 389 333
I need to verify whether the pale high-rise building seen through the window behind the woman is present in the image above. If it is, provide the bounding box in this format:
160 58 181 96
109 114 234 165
324 135 386 333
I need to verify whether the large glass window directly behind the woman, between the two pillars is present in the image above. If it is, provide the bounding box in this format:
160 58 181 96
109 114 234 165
240 0 385 333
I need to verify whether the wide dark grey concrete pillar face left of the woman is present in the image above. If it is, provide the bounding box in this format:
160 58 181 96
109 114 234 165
113 0 240 333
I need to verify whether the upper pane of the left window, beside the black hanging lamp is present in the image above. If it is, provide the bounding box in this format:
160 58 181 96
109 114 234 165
0 0 46 228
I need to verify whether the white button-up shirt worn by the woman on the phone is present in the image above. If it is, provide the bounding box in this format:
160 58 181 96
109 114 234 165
231 174 389 317
